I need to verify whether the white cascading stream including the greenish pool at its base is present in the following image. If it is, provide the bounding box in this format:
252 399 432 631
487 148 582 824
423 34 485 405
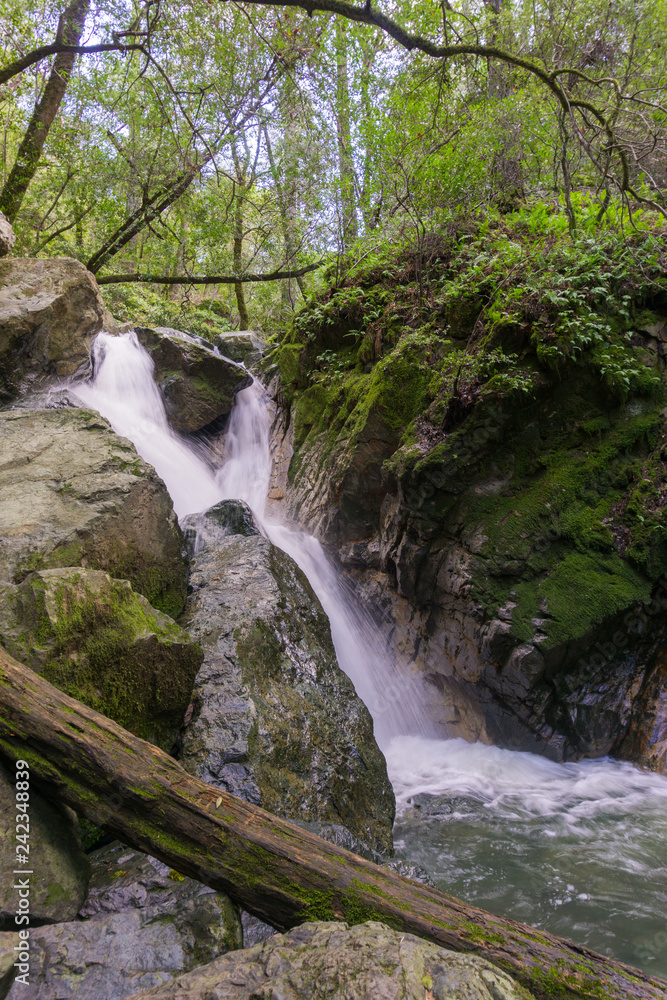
75 333 667 976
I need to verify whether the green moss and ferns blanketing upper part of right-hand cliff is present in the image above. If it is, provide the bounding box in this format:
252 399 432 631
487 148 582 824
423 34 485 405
275 210 667 647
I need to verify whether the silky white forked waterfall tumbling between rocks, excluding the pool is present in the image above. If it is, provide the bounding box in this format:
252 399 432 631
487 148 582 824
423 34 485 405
76 332 431 750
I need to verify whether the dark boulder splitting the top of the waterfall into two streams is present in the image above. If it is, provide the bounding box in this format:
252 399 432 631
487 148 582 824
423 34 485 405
136 327 252 434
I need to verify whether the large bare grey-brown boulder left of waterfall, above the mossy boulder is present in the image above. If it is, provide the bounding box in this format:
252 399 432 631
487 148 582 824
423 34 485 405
0 409 186 617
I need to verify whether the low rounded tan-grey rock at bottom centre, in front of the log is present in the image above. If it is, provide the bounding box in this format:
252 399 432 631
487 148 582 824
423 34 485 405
124 922 530 1000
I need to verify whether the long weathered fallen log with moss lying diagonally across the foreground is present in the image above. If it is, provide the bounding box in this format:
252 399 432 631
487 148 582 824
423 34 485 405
0 649 667 1000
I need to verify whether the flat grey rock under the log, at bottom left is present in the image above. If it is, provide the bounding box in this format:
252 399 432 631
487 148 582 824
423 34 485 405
9 844 241 1000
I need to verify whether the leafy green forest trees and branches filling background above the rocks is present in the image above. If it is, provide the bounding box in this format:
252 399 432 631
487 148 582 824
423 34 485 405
0 0 667 328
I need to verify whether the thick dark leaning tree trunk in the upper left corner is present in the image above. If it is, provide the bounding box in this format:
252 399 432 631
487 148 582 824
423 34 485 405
0 0 90 222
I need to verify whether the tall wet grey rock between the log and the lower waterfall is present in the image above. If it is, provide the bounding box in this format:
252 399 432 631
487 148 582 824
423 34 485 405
181 501 394 854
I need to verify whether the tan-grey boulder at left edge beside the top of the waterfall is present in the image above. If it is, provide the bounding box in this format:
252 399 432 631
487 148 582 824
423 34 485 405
0 257 116 405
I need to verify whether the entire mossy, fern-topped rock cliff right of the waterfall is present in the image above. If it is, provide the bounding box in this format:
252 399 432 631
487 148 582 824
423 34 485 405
275 218 667 767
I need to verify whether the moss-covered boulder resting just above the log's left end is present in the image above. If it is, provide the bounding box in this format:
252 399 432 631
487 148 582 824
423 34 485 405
0 567 203 750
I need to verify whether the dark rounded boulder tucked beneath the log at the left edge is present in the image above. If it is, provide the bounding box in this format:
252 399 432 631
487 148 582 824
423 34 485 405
0 768 90 931
